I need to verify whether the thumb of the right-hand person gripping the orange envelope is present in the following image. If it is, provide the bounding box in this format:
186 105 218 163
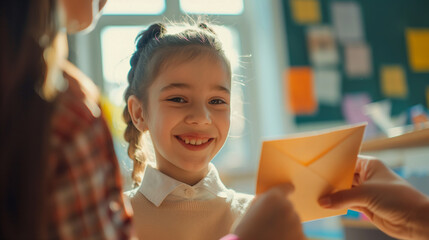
319 187 368 209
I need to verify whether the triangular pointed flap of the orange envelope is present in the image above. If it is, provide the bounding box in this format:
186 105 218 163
267 124 366 166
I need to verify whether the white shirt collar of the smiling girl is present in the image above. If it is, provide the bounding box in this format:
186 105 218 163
139 163 227 207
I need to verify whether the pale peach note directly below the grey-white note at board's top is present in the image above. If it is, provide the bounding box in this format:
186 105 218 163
344 43 372 78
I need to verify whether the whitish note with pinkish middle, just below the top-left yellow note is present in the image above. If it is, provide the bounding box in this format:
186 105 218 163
307 26 339 66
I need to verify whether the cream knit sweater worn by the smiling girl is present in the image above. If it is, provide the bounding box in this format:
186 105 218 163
131 190 251 240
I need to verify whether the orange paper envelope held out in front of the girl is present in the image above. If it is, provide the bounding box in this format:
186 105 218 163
256 123 366 222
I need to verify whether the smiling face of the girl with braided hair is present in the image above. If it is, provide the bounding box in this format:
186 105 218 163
143 55 231 185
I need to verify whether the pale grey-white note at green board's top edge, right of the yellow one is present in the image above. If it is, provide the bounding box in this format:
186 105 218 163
331 1 364 43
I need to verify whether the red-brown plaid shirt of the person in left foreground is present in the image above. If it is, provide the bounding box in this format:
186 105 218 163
48 66 132 240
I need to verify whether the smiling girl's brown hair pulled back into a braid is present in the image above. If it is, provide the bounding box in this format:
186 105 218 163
123 23 231 185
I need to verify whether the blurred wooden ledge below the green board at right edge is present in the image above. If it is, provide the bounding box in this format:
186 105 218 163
361 128 429 152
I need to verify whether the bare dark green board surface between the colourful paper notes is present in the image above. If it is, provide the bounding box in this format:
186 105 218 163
283 0 429 124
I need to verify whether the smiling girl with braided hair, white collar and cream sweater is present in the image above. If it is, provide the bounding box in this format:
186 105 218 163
124 24 253 239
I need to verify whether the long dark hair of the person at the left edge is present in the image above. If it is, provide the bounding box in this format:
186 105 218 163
0 0 58 239
